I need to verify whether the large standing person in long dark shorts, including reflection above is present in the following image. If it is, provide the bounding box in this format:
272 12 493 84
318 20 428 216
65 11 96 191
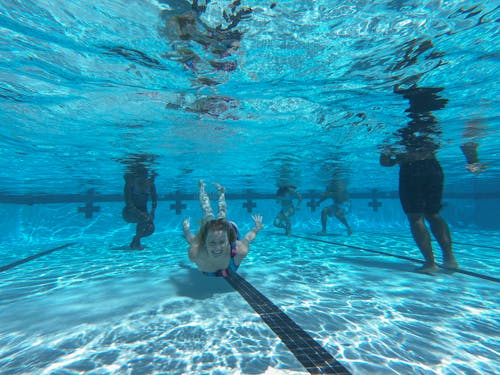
380 85 458 274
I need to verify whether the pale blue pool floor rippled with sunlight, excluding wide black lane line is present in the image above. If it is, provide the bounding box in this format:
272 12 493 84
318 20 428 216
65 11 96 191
0 206 499 374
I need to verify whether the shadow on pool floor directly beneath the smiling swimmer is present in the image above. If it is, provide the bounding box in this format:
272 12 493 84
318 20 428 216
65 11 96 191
169 264 235 300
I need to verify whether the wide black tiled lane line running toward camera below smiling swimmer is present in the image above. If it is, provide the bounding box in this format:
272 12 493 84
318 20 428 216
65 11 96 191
226 274 350 375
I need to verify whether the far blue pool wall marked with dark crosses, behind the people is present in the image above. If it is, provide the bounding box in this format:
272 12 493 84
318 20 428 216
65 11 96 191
0 193 500 243
